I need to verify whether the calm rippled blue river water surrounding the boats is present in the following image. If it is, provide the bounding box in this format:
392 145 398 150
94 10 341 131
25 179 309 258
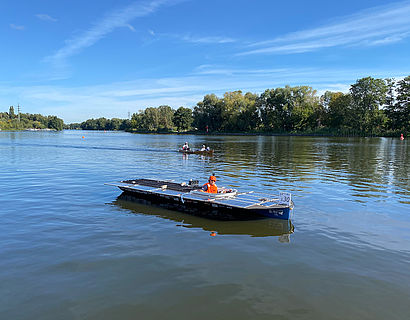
0 131 410 320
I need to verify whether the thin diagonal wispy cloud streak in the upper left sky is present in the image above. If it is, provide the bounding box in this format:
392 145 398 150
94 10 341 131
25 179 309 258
46 0 182 66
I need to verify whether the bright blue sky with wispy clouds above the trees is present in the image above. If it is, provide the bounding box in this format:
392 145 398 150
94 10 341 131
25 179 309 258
0 0 410 123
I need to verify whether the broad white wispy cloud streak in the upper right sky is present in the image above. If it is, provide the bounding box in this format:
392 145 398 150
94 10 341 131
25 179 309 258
239 1 410 55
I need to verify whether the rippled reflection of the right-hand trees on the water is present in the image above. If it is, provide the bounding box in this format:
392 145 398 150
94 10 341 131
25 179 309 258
205 136 410 203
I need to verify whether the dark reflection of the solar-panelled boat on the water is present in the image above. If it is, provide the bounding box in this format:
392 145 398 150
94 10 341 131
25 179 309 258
112 192 294 243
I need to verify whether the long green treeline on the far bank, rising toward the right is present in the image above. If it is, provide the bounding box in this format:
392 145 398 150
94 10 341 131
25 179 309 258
75 76 410 136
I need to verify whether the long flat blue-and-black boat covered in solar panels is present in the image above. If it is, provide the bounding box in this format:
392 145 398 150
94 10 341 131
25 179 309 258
107 179 293 220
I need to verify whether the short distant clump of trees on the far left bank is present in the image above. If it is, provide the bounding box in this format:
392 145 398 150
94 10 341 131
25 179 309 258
0 106 64 131
